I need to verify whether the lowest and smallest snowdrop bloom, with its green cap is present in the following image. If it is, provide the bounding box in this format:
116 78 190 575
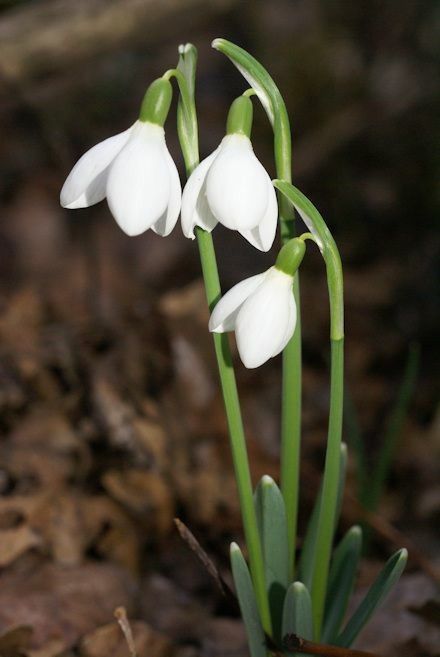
209 238 305 368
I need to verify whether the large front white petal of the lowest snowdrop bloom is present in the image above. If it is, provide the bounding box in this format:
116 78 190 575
235 267 294 368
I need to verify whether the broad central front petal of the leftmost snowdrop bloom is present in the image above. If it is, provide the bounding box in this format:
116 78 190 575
107 121 171 235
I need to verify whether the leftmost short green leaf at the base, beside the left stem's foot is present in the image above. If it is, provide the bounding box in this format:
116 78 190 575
231 543 267 657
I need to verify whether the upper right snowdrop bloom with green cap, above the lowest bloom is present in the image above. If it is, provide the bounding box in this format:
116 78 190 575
182 96 278 251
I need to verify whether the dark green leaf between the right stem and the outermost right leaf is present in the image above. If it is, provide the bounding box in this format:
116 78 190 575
321 525 362 643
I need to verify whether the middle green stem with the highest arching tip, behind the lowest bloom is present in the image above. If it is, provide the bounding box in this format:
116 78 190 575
212 39 302 580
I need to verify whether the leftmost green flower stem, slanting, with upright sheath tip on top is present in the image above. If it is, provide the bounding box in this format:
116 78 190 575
172 44 272 635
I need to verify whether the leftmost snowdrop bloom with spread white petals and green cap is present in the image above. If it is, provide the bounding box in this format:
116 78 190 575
60 78 182 236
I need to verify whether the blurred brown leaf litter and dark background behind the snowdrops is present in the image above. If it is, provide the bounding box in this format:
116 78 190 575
0 0 440 657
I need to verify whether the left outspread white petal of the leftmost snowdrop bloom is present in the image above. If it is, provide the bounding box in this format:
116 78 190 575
60 128 132 210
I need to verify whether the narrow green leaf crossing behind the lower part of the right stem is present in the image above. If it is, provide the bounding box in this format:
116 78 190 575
298 443 347 590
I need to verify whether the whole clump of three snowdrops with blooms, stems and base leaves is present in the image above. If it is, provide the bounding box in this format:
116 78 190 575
61 39 406 657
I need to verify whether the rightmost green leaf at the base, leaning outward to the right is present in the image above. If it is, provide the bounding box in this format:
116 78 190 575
336 549 408 648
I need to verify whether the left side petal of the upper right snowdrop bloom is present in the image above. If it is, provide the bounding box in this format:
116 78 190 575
182 147 220 239
